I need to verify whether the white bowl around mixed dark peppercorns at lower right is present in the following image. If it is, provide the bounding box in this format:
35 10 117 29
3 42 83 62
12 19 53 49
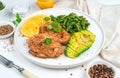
86 60 117 78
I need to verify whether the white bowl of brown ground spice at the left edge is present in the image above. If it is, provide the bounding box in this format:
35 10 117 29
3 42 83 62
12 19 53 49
0 21 15 39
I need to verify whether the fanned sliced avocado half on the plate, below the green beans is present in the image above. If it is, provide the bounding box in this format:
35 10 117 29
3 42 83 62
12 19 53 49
65 30 95 58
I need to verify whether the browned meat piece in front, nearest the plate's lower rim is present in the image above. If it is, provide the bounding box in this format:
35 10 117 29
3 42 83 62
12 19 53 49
27 34 64 58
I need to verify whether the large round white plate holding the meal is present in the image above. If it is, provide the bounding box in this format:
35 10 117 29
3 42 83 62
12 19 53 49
14 8 104 68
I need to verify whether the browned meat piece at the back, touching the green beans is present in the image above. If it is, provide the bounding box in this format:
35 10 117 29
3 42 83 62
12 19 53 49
40 22 70 45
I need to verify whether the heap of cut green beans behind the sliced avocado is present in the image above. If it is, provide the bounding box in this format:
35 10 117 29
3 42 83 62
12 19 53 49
50 12 90 34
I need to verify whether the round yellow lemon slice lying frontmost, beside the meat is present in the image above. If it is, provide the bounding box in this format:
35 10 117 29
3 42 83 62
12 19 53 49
21 22 39 37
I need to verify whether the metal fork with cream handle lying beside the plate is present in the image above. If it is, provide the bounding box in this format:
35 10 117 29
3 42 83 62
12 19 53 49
0 55 40 78
